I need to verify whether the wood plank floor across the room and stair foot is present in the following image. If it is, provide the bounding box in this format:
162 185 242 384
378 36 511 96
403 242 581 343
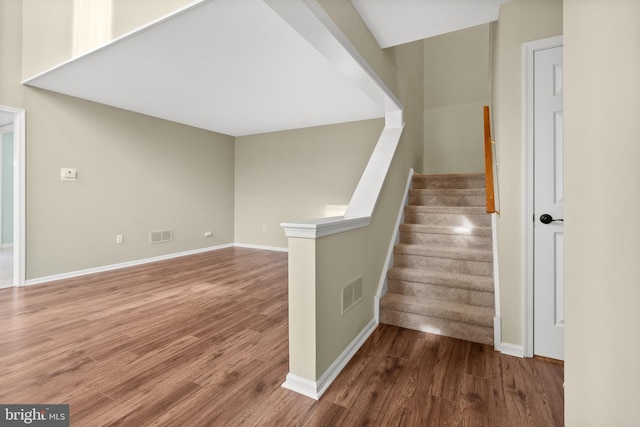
0 248 564 427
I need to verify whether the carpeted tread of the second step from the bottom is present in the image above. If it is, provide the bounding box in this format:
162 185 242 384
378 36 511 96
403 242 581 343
387 267 493 293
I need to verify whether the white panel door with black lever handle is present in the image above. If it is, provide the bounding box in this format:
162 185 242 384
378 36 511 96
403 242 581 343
533 47 564 360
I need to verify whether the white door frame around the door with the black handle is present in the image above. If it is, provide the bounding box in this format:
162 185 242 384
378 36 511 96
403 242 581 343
522 36 563 357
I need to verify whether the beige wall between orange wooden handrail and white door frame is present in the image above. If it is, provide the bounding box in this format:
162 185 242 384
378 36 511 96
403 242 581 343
493 0 562 345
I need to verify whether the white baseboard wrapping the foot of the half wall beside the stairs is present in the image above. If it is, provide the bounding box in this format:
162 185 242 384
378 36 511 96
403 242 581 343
282 319 378 400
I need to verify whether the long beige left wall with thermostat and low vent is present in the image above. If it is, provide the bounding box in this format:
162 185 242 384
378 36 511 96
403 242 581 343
0 2 234 279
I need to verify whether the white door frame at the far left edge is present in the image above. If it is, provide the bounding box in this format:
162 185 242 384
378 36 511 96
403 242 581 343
0 105 26 286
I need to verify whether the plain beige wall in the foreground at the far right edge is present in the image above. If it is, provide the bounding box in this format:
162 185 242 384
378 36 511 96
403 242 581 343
564 0 640 427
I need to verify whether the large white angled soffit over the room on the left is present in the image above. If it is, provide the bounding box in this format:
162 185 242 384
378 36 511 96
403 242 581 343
24 0 385 136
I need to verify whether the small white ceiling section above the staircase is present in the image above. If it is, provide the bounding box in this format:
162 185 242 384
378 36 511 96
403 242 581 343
351 0 510 48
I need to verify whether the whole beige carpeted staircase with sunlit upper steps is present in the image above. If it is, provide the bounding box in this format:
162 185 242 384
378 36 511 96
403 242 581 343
380 174 494 345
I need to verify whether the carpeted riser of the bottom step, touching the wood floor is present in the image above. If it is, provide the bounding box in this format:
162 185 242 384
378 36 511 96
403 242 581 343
380 309 493 345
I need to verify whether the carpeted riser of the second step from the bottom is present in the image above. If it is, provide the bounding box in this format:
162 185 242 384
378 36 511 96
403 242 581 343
387 279 494 309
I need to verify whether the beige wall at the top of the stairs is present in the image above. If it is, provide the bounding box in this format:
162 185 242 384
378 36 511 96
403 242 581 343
424 24 491 173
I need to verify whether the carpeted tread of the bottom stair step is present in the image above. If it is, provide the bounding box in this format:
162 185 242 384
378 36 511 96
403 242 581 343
380 293 494 327
